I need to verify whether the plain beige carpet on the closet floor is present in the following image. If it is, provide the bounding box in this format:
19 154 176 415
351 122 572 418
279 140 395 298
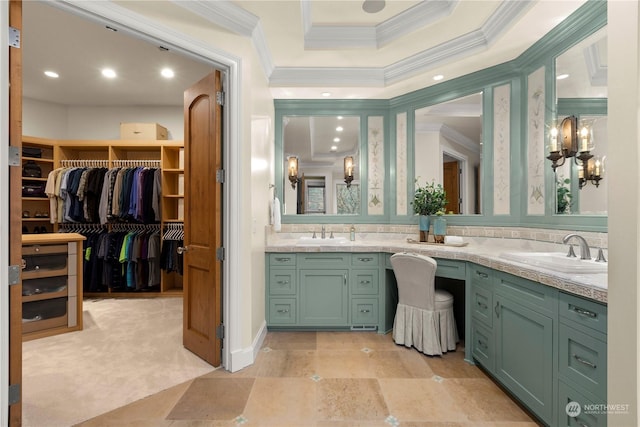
22 298 214 427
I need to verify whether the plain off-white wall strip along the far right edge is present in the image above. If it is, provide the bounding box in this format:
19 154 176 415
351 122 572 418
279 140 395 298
605 1 640 427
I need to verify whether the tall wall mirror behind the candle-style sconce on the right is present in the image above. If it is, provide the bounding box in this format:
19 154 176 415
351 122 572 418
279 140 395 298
547 27 608 215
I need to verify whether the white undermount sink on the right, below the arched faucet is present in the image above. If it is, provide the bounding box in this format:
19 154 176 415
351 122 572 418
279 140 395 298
500 252 607 274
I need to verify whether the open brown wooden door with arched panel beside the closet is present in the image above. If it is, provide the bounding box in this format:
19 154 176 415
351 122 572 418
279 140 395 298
182 71 222 366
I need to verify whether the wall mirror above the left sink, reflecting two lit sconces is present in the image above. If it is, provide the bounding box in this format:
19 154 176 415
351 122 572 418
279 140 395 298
282 115 361 215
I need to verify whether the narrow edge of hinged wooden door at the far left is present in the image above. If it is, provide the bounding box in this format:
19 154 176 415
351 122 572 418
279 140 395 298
4 0 22 426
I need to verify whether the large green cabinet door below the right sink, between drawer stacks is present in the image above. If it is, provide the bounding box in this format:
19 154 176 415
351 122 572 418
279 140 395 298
494 294 554 424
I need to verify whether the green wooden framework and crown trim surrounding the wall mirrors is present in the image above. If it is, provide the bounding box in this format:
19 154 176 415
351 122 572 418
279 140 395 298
274 0 607 232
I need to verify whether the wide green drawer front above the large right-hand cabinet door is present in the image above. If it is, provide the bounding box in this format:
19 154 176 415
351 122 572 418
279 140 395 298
494 271 558 316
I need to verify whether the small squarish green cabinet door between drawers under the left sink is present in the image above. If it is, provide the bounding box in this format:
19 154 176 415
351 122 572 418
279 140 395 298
298 269 349 327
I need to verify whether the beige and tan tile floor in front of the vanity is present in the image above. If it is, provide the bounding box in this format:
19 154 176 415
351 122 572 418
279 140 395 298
79 332 537 427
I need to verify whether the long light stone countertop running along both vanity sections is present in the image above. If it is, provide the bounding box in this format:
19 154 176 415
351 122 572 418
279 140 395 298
265 237 607 304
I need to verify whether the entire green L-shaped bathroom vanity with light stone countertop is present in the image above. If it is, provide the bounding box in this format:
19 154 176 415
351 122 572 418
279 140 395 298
265 239 607 426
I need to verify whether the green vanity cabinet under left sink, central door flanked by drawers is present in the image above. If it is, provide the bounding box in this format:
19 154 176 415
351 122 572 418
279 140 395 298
266 252 386 332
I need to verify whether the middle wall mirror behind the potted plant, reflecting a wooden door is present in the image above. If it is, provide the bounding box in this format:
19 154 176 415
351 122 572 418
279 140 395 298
411 92 482 214
